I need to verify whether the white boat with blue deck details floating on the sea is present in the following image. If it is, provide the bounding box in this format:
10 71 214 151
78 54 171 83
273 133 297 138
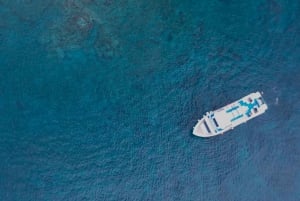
193 92 268 137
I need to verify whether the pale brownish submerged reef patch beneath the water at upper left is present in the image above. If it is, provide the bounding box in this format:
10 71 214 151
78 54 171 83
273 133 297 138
39 0 119 58
